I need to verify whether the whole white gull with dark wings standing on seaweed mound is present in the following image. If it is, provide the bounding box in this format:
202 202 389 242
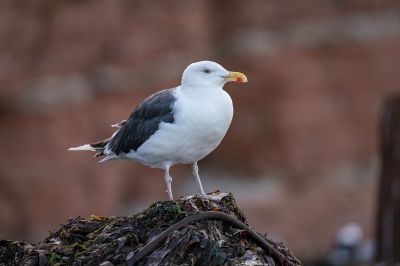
69 61 247 200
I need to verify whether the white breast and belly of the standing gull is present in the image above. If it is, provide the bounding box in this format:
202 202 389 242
135 89 233 168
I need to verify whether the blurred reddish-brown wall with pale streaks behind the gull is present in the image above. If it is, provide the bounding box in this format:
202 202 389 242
0 0 400 261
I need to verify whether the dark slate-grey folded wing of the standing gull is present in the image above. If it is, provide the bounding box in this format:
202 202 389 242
108 89 176 155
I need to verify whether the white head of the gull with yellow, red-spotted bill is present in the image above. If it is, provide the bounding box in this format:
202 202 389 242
182 61 247 88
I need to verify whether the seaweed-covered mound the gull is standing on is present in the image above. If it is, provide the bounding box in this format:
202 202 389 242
0 192 300 266
